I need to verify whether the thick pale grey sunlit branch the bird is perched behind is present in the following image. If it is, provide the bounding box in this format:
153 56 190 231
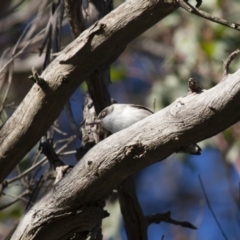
12 70 240 240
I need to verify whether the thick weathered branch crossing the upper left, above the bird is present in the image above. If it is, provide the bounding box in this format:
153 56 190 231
0 0 178 182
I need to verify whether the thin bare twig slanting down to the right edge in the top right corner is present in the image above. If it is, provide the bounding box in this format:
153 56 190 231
177 0 240 31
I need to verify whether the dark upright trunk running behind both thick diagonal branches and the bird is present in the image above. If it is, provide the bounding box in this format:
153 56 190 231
65 0 147 240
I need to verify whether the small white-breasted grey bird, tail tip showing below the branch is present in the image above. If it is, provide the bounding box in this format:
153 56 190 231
95 103 201 155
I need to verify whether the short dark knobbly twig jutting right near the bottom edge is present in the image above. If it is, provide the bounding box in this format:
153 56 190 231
147 211 197 229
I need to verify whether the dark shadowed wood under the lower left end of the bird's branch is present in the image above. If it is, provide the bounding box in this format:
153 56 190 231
13 206 105 240
